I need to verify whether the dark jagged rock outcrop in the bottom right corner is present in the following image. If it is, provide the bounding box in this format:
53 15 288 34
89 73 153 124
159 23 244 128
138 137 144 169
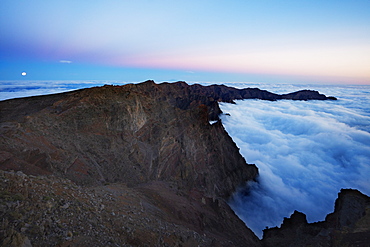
262 189 370 246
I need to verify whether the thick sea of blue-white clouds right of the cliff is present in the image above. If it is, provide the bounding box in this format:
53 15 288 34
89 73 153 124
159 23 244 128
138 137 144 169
220 87 370 237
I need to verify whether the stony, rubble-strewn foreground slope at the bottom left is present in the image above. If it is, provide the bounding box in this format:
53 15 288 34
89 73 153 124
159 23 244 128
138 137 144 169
0 171 259 247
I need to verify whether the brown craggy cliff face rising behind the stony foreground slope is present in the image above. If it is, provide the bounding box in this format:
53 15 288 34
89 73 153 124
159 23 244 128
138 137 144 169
0 82 257 198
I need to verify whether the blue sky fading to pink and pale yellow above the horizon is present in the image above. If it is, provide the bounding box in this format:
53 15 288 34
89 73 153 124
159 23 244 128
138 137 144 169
0 0 370 84
